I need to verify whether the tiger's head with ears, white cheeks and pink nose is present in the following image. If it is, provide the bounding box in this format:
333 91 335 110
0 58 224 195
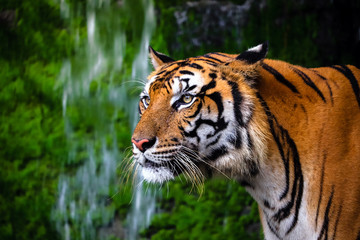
132 43 267 183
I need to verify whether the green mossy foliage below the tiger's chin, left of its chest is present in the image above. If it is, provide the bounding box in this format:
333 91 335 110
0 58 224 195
142 179 261 240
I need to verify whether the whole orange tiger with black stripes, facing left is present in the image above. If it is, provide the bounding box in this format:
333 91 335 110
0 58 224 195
131 42 360 240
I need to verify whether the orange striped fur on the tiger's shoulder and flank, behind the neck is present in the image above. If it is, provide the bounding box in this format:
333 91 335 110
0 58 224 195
306 0 360 66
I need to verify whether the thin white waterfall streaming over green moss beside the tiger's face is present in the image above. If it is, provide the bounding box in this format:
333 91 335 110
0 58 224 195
52 0 156 240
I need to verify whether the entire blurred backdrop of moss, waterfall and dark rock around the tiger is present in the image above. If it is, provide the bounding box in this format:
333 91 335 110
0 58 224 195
0 0 360 240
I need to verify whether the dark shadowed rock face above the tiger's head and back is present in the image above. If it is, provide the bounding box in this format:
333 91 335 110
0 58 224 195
158 0 360 66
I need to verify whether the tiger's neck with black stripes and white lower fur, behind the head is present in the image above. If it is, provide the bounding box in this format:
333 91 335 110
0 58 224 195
239 62 311 239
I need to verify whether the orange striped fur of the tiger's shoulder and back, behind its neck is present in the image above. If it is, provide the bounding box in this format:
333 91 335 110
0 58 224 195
259 60 360 239
